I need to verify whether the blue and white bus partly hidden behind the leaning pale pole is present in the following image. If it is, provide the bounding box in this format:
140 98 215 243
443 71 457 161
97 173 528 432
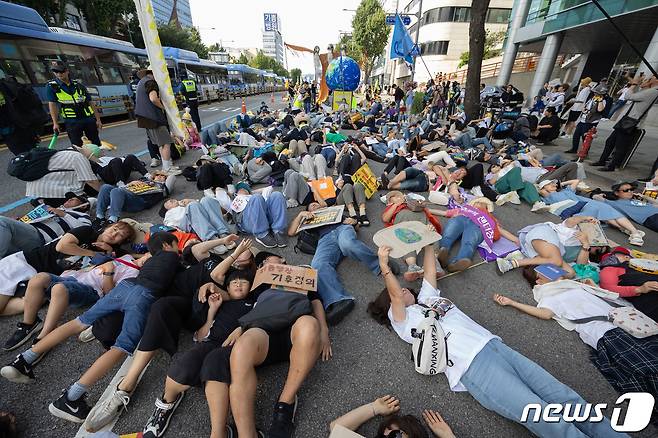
162 47 229 102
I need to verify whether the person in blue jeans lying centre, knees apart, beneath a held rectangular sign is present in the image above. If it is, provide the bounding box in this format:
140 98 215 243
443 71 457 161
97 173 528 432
288 206 390 325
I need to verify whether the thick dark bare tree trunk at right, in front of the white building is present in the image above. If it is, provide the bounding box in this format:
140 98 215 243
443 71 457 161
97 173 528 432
464 0 489 120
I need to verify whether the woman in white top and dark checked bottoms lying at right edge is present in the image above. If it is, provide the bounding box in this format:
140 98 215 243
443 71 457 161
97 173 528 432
493 273 658 424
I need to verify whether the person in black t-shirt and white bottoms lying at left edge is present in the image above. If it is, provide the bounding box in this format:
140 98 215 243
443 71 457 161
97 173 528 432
0 222 135 316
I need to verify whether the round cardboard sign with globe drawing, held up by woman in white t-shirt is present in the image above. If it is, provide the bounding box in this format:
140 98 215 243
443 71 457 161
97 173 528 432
372 221 441 259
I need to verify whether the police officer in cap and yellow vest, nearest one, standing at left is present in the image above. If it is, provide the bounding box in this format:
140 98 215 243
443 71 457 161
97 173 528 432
46 61 103 146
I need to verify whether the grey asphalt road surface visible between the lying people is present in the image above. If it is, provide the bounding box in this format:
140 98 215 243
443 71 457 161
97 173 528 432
0 95 658 438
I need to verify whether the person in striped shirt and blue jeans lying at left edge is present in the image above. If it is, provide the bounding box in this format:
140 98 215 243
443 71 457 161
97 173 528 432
0 192 91 258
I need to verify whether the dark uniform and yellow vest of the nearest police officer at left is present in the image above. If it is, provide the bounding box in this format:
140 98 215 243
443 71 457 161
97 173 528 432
46 79 101 146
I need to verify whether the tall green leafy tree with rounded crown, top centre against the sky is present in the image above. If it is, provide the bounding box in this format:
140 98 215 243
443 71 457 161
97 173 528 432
352 0 391 83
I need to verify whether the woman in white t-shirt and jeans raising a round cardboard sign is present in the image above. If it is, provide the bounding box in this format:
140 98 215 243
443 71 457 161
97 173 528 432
368 245 623 438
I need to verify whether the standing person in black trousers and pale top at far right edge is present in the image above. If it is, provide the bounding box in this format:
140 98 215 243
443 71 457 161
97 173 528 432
592 76 658 172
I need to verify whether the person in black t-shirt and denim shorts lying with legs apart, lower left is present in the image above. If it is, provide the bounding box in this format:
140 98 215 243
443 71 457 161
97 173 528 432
0 232 179 423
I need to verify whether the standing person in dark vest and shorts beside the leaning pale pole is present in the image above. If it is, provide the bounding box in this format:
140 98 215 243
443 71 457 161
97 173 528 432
135 68 178 171
